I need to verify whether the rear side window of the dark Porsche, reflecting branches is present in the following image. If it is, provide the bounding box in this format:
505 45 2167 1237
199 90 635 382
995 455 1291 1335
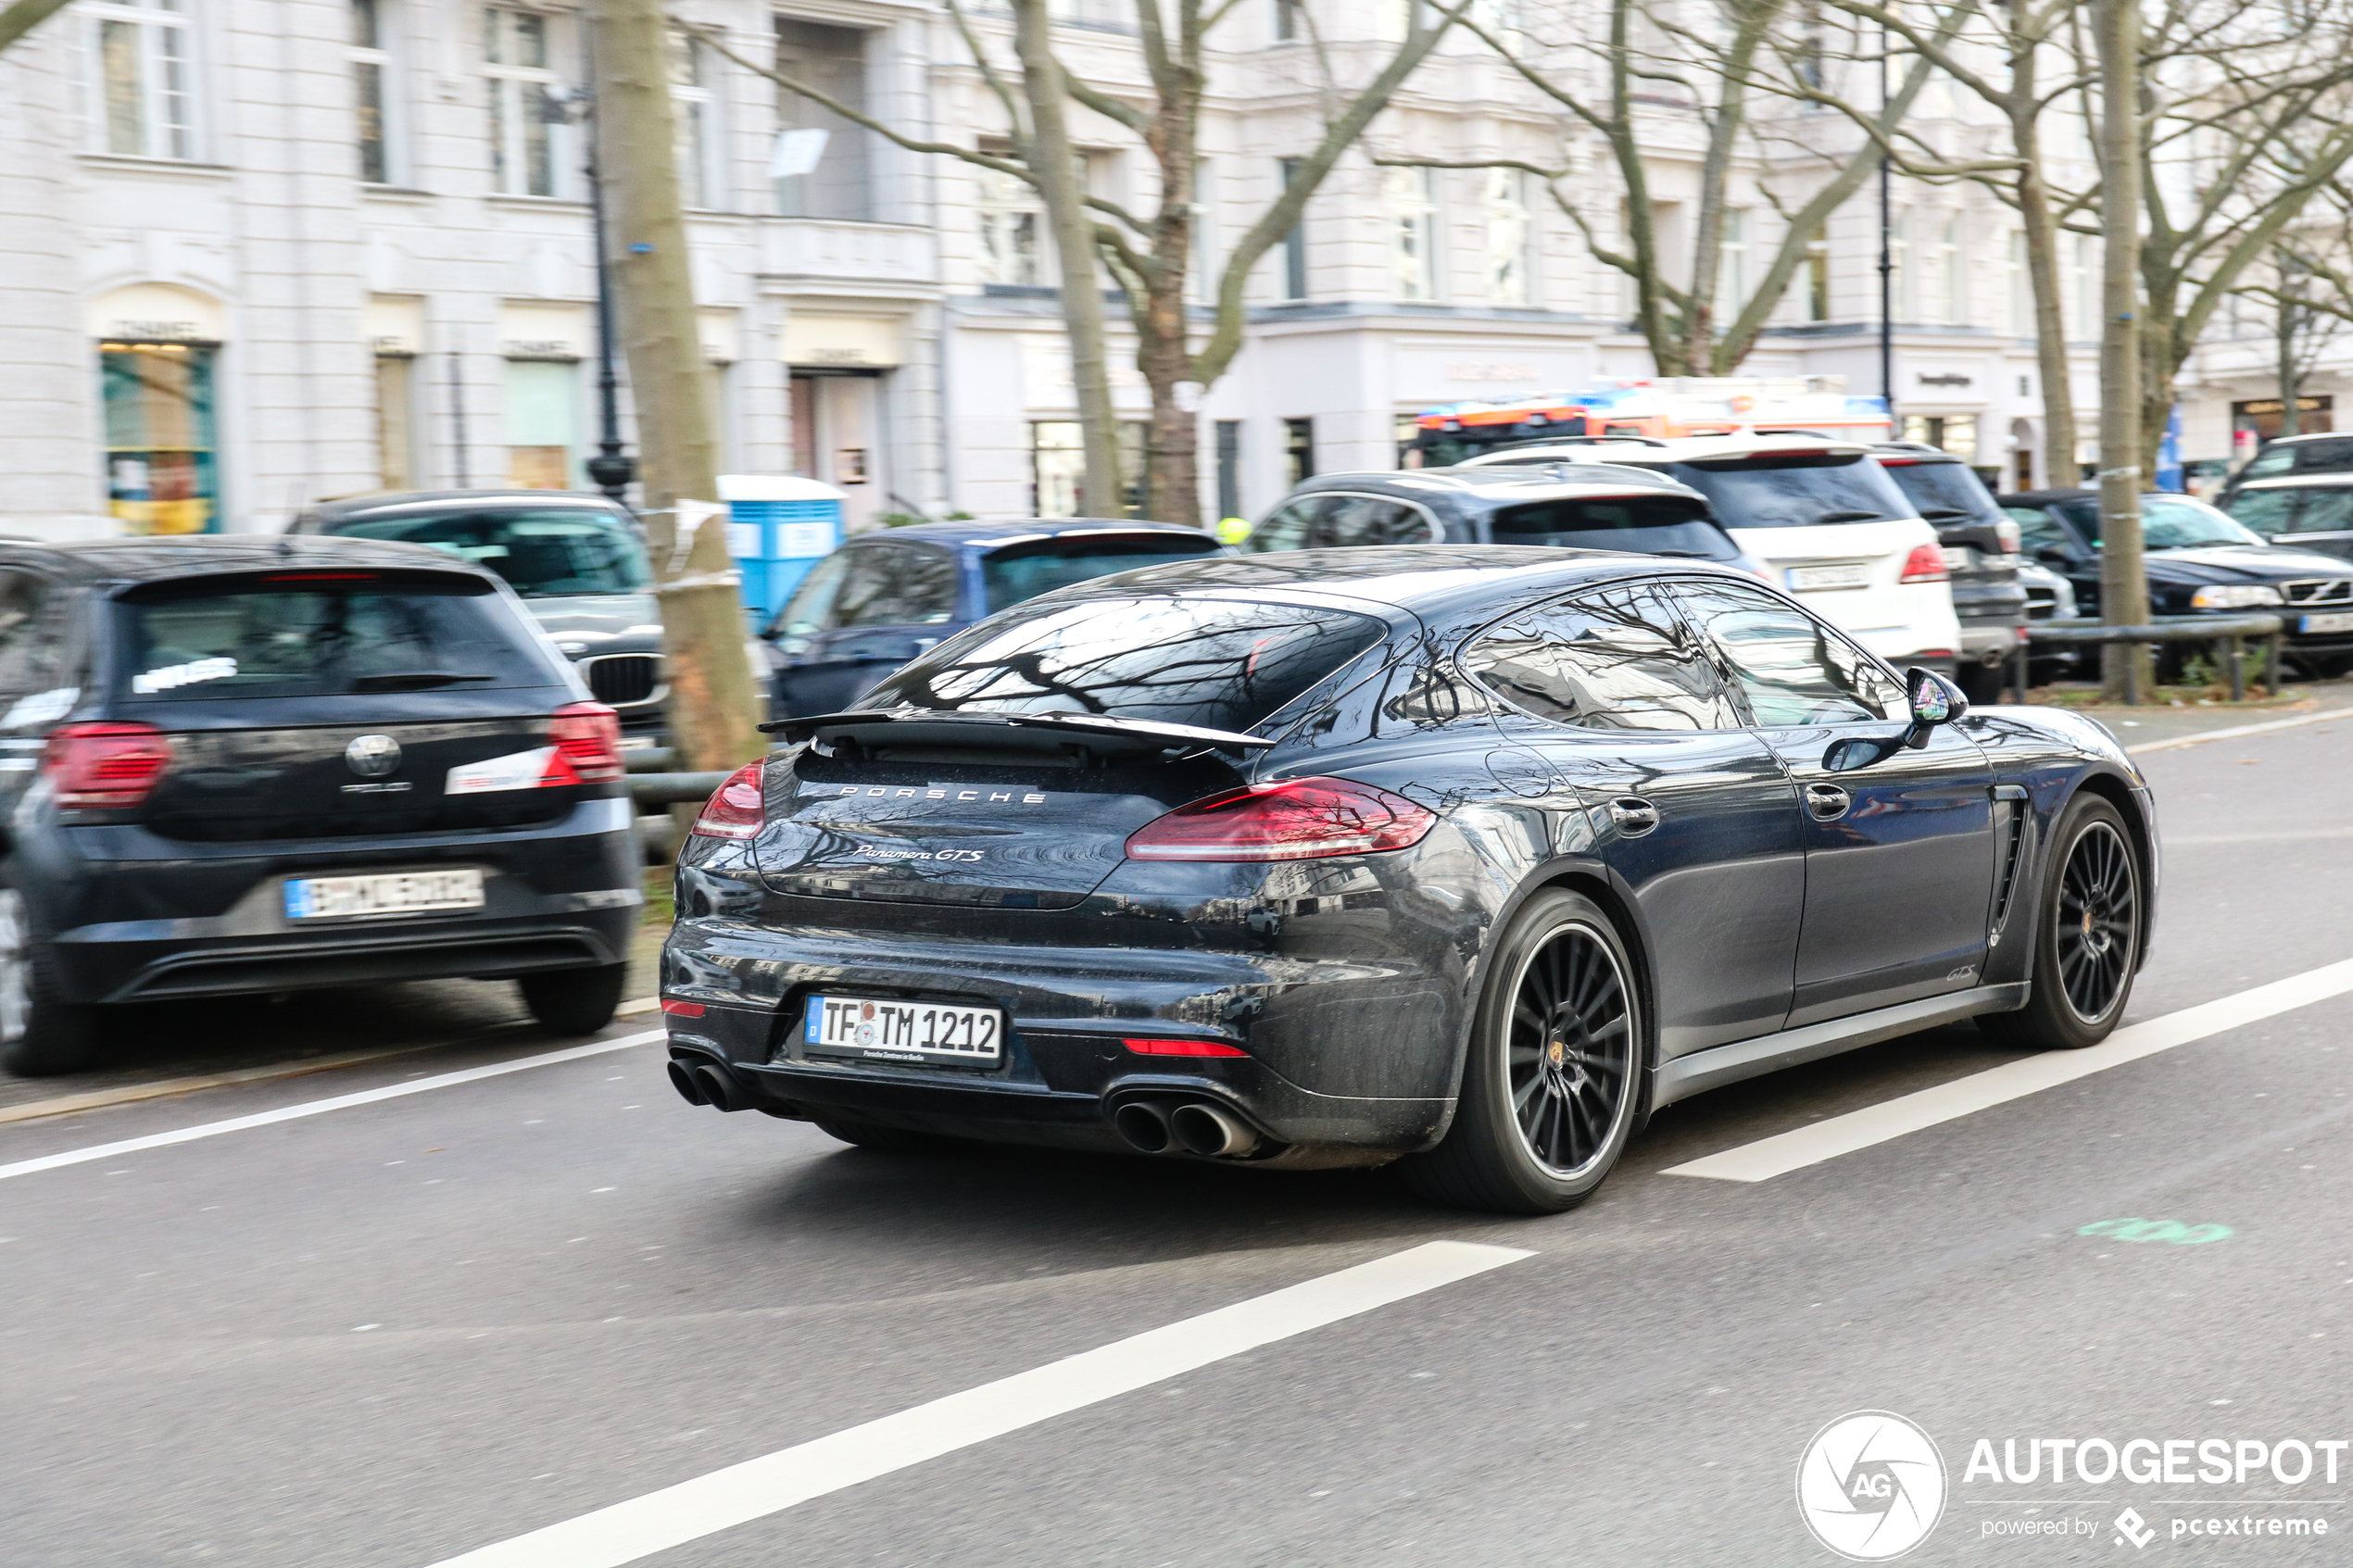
1464 585 1739 731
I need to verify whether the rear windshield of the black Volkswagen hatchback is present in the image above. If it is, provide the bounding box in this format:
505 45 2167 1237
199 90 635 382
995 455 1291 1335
115 571 562 703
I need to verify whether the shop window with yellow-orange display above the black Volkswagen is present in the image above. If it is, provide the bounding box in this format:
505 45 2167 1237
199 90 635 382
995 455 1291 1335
99 344 221 533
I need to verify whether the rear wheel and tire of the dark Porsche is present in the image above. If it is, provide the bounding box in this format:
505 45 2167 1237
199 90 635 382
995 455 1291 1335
1398 888 1650 1213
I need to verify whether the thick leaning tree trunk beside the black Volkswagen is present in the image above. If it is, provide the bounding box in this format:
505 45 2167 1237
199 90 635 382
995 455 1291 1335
591 0 767 771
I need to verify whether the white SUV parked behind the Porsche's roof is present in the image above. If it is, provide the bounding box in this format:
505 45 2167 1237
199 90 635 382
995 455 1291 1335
1461 430 1960 672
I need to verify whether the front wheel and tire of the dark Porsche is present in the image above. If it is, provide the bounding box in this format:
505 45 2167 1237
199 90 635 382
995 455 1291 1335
1977 795 2148 1051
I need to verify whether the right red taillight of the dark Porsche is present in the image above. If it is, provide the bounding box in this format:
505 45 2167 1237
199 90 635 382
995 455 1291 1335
1127 778 1438 860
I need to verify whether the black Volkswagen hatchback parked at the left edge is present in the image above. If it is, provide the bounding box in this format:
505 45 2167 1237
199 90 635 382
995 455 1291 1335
0 536 645 1074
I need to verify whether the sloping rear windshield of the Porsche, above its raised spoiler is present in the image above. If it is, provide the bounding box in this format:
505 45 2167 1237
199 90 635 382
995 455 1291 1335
859 599 1386 731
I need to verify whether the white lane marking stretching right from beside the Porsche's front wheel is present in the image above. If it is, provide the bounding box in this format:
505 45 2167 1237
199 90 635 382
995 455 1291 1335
1661 960 2353 1183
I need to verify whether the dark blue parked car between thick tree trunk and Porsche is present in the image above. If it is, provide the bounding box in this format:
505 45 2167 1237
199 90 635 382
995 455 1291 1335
760 517 1224 717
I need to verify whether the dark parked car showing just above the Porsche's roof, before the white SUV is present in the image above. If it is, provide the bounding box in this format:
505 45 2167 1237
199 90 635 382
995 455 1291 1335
1240 463 1765 576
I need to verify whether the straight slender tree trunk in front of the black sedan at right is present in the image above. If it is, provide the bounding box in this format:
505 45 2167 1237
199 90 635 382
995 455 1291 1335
2096 0 2148 703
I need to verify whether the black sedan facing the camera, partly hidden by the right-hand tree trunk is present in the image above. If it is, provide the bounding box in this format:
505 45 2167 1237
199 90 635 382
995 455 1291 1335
2000 489 2353 680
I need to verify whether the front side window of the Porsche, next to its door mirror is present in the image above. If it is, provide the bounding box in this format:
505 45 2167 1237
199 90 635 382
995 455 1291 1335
1680 583 1904 726
